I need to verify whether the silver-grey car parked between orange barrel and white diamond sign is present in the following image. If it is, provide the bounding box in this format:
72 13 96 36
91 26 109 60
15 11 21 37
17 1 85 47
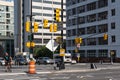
37 57 54 64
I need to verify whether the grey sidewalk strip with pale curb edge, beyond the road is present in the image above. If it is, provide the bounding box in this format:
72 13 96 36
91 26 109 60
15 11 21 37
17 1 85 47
0 63 120 76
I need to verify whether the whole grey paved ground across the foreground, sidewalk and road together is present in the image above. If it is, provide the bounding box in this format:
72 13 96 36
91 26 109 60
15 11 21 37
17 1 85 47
0 64 120 80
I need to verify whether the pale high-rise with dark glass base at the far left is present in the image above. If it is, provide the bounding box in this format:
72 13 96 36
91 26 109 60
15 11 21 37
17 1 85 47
0 0 14 56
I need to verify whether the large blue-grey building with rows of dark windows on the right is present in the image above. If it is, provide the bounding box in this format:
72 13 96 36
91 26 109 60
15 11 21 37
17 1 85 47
66 0 120 62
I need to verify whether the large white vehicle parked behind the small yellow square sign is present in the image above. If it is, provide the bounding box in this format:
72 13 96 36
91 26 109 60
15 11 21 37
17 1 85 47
54 53 72 63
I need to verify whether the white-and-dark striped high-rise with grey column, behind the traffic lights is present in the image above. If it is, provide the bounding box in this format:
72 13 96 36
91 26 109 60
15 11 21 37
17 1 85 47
14 0 66 52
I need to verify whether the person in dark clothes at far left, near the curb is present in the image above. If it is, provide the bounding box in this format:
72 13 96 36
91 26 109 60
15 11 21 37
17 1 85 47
4 52 11 72
